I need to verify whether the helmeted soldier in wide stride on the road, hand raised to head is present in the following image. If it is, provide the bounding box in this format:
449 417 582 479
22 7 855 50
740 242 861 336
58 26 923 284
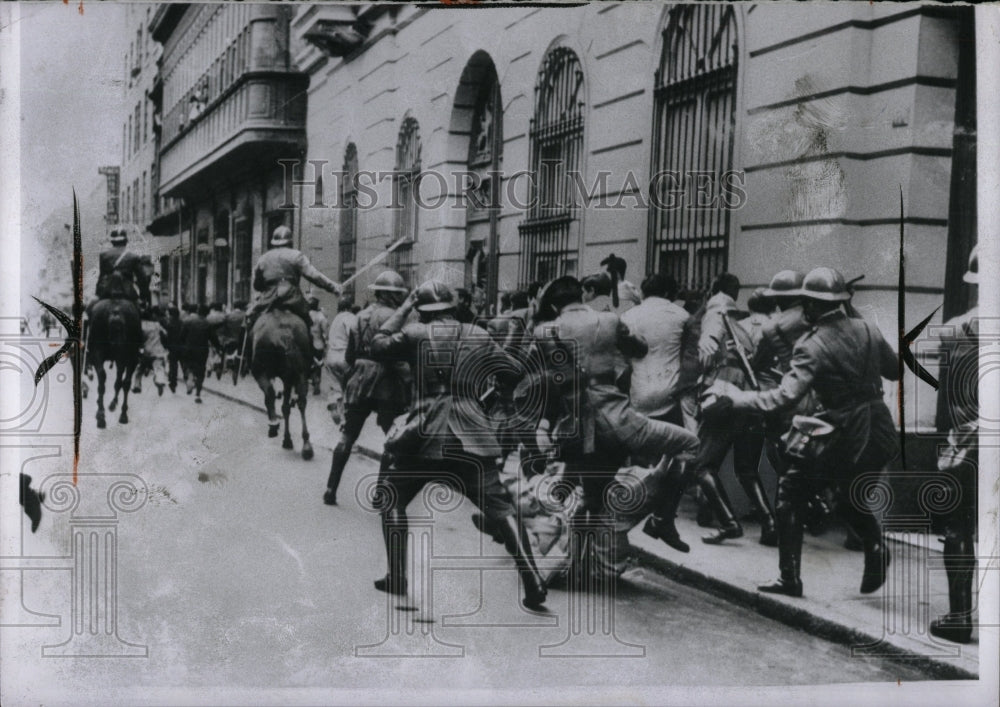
371 280 546 609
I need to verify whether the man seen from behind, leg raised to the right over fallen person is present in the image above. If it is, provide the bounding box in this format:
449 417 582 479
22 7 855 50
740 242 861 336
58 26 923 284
534 276 698 559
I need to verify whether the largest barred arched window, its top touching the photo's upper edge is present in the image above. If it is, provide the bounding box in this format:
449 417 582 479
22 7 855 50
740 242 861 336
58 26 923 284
646 3 738 290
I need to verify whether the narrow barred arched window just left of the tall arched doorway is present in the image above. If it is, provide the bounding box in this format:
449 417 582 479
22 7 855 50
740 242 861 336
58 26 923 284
389 117 420 287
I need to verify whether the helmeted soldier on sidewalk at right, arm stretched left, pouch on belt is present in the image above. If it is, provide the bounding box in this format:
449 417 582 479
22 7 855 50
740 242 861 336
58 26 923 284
702 268 899 597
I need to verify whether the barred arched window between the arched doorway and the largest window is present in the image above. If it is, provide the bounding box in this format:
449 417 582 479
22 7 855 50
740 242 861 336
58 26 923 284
519 47 585 283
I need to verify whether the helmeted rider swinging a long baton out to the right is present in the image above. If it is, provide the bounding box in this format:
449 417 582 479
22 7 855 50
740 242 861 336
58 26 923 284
247 226 340 330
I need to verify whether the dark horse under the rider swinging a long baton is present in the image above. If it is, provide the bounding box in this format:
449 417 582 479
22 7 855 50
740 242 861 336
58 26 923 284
250 308 313 460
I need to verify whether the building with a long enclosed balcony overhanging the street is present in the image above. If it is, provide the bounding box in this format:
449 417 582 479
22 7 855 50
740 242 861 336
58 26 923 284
150 3 307 304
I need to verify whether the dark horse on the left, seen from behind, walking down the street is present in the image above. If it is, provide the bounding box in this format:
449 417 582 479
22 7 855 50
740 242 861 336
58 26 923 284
87 298 142 430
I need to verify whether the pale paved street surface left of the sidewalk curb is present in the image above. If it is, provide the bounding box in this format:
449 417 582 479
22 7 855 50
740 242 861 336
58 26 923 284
3 367 936 704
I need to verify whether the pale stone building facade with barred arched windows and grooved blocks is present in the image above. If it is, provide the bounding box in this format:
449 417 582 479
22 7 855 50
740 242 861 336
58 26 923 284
292 3 975 432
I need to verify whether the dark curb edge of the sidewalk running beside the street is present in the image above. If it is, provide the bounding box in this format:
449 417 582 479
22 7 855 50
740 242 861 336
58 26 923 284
202 386 979 680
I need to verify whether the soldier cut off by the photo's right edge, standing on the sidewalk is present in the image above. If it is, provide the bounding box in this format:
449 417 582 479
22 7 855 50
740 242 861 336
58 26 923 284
930 246 979 643
